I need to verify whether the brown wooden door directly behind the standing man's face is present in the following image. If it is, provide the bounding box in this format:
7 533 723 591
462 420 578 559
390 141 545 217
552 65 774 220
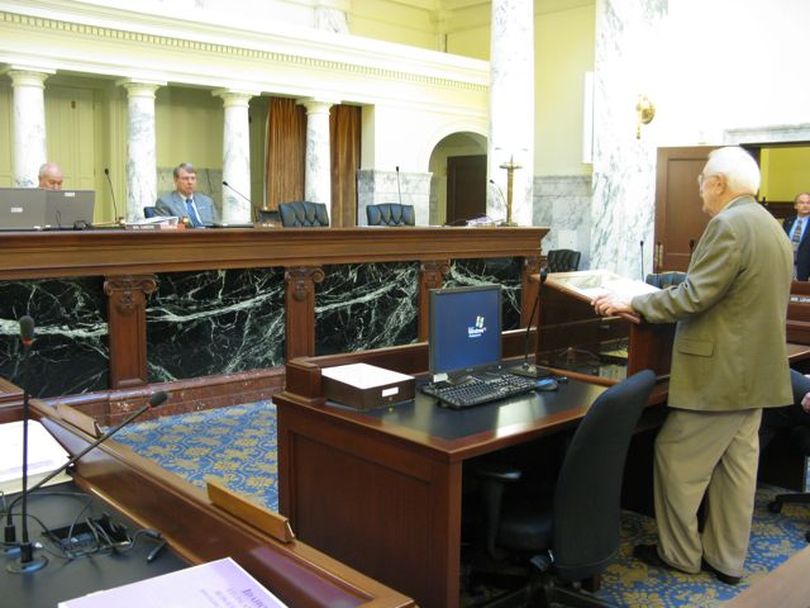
653 146 714 272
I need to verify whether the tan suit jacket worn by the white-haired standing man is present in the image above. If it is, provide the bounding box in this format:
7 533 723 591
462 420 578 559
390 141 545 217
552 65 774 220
632 196 793 411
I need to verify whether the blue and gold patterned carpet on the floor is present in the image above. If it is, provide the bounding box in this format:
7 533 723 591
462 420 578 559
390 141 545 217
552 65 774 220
116 401 810 608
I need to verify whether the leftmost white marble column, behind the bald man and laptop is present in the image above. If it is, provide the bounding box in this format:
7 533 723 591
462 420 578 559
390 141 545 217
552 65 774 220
6 66 54 188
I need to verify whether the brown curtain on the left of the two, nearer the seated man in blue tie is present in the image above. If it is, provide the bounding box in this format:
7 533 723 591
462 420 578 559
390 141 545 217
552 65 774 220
266 97 307 210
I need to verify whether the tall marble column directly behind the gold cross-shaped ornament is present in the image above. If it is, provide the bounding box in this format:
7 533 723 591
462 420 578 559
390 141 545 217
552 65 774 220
487 0 534 225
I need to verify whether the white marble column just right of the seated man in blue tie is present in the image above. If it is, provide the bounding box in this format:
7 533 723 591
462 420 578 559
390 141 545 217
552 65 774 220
213 89 257 224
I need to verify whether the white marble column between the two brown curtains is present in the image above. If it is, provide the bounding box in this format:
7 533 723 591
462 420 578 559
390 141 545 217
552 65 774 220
298 99 332 207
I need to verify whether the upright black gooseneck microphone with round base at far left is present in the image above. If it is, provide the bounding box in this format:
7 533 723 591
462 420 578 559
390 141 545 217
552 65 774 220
6 315 48 574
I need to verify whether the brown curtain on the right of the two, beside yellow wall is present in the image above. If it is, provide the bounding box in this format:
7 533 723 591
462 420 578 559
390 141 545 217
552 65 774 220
329 105 360 226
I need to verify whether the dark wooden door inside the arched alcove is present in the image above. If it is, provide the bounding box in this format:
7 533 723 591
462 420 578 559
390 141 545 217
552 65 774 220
446 154 487 224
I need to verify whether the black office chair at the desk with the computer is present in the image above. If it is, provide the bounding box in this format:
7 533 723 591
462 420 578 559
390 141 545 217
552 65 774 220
474 370 655 606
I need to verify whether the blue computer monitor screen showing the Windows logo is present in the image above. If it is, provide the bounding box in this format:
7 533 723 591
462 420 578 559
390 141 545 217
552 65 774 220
428 285 501 374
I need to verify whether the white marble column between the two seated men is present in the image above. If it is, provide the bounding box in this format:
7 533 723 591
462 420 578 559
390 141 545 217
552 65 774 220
119 80 166 221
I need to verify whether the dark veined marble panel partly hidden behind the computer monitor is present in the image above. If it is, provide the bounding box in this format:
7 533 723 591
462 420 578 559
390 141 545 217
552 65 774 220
444 258 523 331
